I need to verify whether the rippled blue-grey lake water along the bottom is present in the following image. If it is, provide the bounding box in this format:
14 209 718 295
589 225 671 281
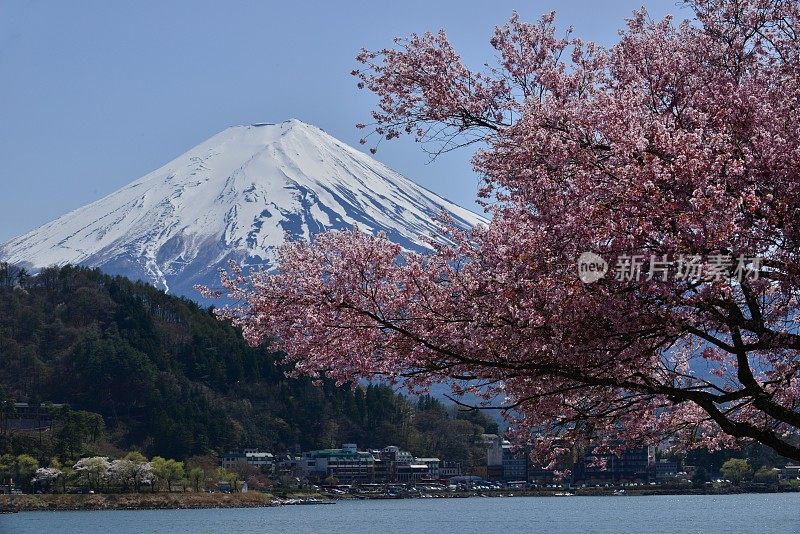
0 493 800 534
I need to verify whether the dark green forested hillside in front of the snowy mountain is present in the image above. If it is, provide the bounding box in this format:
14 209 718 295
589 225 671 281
0 264 496 461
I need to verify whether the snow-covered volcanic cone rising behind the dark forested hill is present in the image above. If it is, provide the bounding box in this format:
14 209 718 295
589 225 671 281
0 119 483 297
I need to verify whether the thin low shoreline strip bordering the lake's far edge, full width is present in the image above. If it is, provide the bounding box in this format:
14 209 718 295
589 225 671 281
0 486 800 513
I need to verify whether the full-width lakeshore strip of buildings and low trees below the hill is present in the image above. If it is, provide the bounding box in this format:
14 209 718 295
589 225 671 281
0 403 800 510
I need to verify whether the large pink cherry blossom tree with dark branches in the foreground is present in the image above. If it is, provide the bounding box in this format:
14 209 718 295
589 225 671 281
202 0 800 460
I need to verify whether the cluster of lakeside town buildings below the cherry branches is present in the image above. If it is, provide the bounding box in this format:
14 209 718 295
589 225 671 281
216 440 800 498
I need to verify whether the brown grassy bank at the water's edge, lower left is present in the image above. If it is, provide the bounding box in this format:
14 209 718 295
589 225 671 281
0 492 276 512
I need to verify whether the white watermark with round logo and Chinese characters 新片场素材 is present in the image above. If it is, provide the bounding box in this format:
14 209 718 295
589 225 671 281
578 252 763 284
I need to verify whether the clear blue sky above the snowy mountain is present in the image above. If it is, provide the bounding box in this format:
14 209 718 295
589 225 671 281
0 0 679 242
